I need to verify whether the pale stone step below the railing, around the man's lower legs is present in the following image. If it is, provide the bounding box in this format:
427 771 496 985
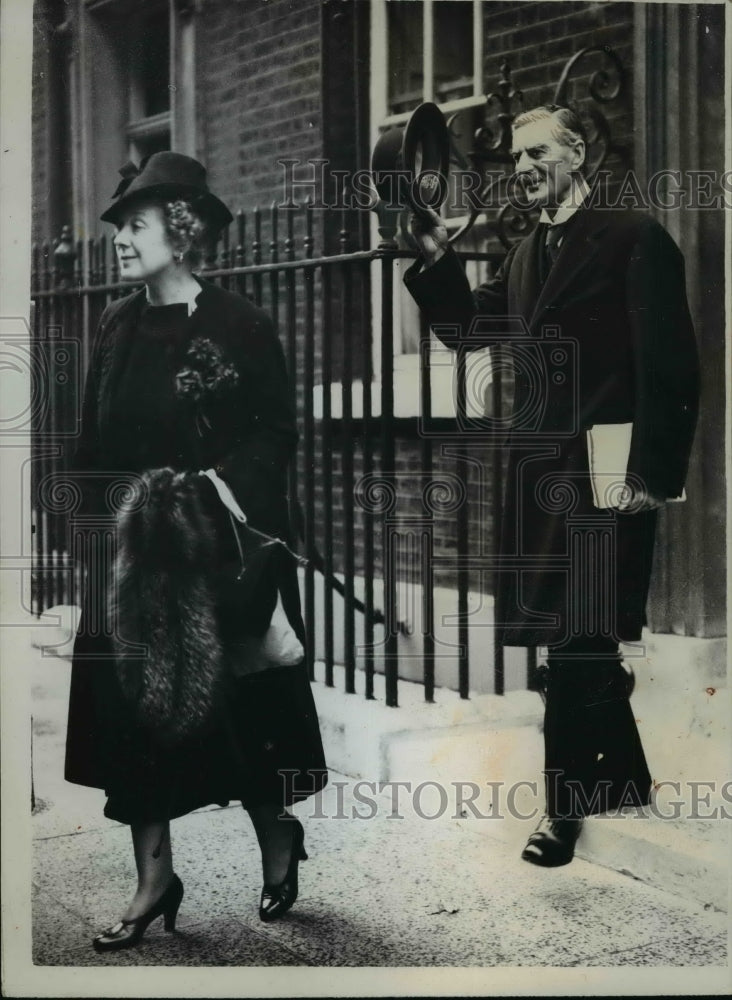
314 667 732 911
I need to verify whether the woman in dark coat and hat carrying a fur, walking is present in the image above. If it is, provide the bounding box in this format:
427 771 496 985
66 153 327 951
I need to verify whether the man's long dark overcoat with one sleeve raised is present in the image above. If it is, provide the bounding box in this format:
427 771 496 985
405 207 698 646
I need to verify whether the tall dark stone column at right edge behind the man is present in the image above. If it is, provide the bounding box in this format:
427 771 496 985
635 3 726 637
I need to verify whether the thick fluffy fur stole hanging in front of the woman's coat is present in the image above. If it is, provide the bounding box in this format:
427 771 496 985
107 468 224 745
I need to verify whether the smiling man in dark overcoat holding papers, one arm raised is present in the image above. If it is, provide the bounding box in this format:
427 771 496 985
405 105 698 866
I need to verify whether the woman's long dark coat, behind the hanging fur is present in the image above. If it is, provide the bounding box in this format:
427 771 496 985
66 281 326 822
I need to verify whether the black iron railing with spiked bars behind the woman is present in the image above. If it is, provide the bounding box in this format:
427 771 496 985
32 206 533 705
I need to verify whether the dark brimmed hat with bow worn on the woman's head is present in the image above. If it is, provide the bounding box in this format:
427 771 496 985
101 152 233 231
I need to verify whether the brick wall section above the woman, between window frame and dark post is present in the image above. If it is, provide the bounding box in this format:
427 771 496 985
196 0 323 220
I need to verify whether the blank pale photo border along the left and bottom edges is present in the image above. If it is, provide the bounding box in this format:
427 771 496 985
0 0 732 997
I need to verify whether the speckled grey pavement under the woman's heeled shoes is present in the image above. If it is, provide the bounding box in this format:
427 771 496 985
28 624 728 976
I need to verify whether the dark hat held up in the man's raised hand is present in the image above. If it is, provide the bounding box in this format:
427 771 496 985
371 101 450 211
